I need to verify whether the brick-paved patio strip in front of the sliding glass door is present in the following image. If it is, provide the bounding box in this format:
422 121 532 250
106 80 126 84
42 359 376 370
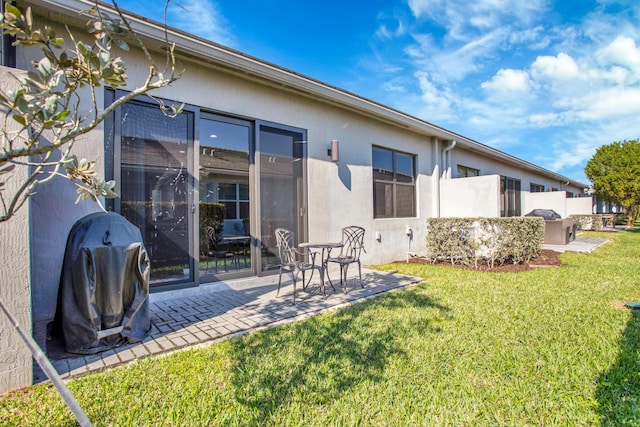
34 268 422 383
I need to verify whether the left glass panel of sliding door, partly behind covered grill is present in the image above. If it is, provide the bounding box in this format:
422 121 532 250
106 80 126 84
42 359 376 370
120 102 194 285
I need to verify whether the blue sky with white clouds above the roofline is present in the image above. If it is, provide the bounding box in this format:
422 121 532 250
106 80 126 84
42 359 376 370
118 0 640 183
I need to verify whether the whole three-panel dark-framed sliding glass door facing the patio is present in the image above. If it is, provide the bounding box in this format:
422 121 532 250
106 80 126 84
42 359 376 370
115 94 307 288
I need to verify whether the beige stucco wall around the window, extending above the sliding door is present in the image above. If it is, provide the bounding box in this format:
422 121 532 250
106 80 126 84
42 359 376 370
115 50 432 264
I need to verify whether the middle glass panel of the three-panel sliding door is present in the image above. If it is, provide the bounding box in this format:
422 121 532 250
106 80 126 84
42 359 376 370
198 114 252 281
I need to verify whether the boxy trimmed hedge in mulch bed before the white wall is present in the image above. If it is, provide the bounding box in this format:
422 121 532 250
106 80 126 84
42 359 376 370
426 217 544 268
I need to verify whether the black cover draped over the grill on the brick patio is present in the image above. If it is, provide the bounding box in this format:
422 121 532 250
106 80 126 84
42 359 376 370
56 212 151 354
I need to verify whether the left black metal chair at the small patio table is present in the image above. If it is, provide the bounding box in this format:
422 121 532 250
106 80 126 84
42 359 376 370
275 228 326 304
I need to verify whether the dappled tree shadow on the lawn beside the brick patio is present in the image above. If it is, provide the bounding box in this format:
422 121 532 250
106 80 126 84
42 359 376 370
232 291 450 424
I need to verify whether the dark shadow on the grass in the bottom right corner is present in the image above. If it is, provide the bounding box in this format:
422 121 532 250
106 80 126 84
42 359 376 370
596 310 640 426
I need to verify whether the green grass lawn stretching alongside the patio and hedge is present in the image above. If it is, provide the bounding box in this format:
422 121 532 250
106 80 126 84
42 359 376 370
0 228 640 426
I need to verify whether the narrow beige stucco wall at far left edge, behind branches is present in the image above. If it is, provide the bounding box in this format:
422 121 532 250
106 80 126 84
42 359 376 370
0 67 33 394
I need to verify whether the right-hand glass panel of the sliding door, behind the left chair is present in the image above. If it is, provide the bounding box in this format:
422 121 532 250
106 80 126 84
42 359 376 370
259 125 306 271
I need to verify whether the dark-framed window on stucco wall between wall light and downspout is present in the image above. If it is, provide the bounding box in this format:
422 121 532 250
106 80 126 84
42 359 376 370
373 147 416 218
